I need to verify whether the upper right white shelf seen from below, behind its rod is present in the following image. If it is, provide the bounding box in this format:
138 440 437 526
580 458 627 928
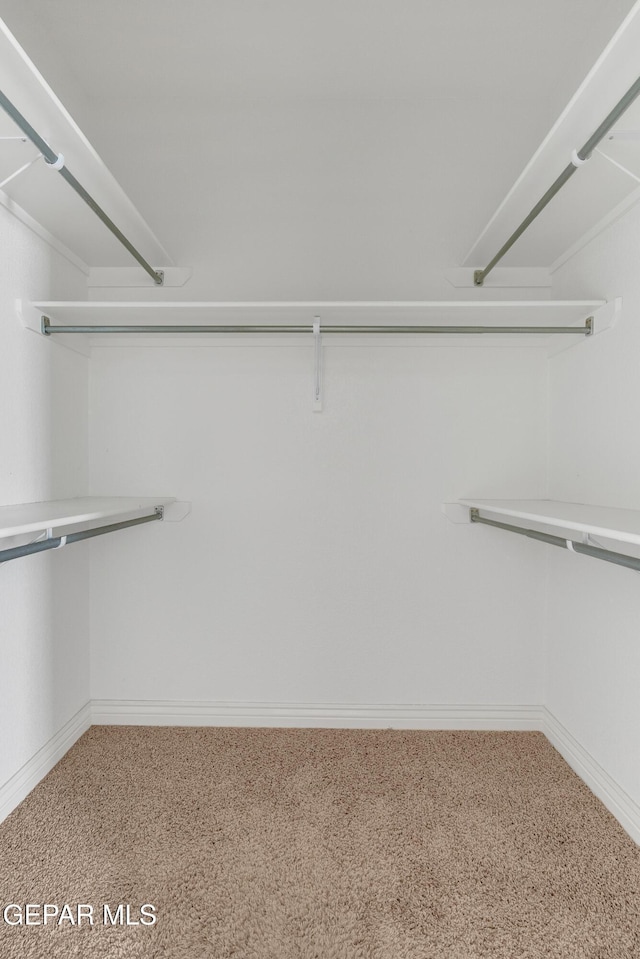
463 3 640 272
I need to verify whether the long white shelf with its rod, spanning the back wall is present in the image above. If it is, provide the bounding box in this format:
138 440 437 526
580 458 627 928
21 300 620 351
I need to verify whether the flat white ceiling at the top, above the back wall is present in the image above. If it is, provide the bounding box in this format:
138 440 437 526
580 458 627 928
0 0 631 102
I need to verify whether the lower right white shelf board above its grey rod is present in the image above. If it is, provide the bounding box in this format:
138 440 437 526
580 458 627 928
443 499 640 546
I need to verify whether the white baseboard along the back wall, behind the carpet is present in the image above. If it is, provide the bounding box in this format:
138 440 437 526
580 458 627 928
91 699 542 729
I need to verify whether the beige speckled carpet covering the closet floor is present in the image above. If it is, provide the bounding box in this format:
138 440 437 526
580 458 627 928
0 727 640 959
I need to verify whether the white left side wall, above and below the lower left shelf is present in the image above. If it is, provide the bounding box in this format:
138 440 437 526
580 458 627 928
0 207 89 787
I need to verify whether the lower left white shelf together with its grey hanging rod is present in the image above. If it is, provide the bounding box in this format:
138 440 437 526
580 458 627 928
0 496 189 563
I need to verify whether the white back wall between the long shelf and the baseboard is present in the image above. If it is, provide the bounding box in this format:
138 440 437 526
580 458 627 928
90 345 546 704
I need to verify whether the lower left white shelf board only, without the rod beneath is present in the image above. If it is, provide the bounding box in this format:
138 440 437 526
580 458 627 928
0 496 177 539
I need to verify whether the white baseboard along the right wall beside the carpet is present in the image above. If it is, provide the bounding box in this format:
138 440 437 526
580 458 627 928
542 707 640 845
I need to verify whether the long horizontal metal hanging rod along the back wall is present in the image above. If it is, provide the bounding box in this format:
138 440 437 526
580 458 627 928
41 316 593 336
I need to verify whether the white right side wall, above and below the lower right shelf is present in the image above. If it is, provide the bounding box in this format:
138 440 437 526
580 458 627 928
546 207 640 802
